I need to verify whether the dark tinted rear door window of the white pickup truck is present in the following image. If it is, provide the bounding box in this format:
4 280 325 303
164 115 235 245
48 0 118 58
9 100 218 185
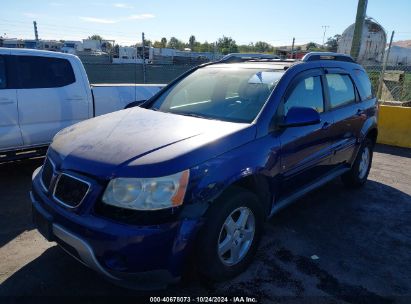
18 56 76 89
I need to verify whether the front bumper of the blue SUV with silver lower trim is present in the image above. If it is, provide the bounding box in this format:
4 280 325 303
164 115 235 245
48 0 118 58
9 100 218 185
30 170 200 289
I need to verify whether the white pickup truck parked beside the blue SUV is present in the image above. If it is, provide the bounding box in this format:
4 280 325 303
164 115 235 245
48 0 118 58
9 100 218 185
0 48 161 161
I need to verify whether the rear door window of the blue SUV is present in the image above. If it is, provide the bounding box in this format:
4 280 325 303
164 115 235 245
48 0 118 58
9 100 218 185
325 74 355 109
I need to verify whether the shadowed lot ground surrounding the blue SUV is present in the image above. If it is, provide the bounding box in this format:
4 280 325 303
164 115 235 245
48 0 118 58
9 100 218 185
0 146 411 304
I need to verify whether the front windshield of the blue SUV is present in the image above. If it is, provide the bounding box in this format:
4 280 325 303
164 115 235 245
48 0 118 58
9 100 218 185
150 67 284 123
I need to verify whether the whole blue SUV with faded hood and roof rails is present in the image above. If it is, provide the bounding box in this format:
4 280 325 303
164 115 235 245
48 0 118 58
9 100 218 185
31 53 378 286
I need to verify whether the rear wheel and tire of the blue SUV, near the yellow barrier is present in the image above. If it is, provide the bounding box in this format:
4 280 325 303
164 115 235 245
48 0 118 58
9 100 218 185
341 137 374 188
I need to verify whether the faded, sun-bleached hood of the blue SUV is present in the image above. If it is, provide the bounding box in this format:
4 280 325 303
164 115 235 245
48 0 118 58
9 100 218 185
49 107 255 178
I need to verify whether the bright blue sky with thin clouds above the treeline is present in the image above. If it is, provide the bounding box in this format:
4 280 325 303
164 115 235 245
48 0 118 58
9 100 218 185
0 0 411 46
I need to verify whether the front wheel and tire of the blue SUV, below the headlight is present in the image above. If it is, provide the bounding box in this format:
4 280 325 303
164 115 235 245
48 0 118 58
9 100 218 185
196 187 265 281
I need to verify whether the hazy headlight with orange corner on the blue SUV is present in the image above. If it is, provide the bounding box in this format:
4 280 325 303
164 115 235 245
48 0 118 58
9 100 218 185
102 170 190 210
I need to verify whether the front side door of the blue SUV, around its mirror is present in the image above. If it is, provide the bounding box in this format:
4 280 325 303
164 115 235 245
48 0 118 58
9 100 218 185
275 69 334 197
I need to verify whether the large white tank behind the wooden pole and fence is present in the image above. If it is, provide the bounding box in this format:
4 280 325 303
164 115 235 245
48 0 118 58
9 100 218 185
338 18 387 64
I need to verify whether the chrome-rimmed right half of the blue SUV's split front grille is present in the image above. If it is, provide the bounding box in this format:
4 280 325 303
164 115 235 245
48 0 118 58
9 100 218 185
54 173 90 208
